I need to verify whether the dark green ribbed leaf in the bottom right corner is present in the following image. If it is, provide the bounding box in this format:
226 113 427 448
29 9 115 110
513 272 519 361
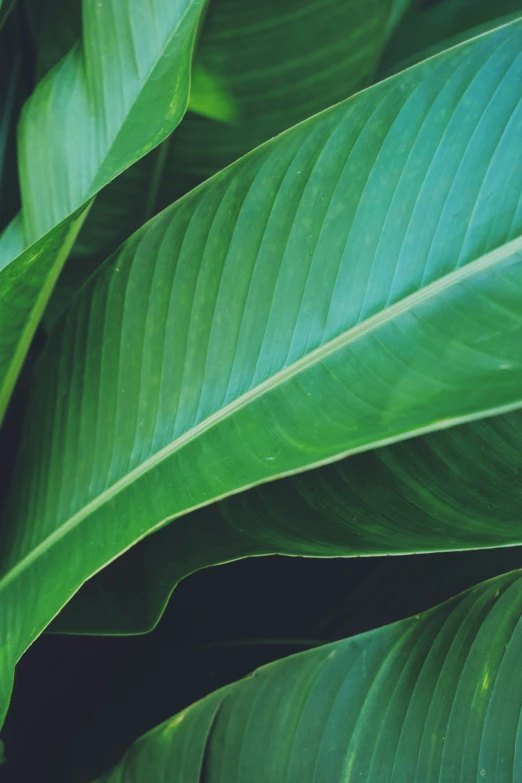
93 571 522 783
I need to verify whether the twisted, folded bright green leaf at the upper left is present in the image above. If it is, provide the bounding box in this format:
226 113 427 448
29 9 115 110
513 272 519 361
0 0 204 416
